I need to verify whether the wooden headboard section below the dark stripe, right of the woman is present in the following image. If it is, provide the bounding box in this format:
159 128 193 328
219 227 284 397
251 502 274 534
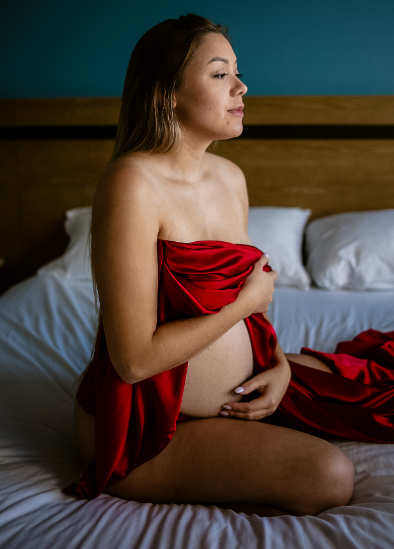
217 140 394 218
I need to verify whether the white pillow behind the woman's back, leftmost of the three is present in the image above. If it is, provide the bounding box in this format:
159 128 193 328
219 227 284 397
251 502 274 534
37 208 92 280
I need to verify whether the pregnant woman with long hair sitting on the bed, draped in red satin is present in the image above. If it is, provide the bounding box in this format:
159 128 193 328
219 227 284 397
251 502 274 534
66 15 393 516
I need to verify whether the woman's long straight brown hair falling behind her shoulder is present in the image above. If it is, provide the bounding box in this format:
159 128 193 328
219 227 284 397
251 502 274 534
111 13 230 161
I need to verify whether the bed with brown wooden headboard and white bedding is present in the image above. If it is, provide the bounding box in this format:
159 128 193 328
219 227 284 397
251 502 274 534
0 97 394 549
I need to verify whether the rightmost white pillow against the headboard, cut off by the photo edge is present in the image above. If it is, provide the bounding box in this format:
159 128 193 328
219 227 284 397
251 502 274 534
306 210 394 290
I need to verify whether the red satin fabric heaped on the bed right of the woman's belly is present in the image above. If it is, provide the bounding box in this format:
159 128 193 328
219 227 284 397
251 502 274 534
273 330 394 444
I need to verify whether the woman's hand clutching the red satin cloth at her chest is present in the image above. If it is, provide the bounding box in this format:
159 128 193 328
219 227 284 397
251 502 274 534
238 254 278 316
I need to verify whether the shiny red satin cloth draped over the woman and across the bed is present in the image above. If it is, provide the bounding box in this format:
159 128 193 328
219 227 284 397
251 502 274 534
65 240 394 498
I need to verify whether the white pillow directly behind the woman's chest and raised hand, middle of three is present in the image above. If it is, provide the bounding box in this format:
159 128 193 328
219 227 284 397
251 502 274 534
248 207 311 289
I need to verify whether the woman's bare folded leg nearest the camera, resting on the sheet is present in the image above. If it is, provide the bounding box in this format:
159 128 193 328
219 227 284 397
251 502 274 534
107 418 353 514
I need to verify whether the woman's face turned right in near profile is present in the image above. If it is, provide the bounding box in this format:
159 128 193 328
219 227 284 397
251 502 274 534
173 33 247 146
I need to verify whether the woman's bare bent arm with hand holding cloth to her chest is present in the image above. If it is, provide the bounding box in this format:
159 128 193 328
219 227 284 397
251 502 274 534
92 166 276 383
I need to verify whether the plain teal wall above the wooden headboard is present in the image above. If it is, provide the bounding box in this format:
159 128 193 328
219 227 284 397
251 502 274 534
0 0 394 98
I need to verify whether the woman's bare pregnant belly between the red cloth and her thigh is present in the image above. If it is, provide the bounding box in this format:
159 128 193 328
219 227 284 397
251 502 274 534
181 320 253 417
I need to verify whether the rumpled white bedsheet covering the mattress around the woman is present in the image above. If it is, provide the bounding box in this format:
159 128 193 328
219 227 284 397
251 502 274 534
0 277 394 549
